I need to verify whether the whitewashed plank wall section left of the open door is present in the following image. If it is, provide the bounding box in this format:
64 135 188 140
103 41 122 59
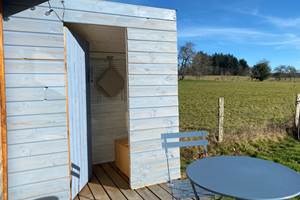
4 1 70 199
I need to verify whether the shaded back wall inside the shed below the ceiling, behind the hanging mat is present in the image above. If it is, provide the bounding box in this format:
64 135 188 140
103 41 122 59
90 52 128 163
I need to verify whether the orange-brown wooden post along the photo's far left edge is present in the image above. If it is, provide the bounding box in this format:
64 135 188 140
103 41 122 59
0 0 8 200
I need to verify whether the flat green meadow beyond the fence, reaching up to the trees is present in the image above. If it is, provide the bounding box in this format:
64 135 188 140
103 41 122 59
179 77 300 133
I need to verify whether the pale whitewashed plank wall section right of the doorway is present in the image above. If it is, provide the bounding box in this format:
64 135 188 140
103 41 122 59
127 27 180 188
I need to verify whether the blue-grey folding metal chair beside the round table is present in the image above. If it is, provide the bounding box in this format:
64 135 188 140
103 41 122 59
161 131 215 199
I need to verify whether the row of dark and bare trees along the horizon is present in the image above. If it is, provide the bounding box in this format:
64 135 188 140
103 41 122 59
178 42 299 81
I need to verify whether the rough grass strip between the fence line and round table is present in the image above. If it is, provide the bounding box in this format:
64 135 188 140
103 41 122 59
181 136 300 172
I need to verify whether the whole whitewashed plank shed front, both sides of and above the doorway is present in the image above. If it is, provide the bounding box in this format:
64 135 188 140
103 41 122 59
4 0 180 196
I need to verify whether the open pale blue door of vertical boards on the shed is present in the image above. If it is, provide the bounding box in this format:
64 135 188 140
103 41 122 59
64 27 91 199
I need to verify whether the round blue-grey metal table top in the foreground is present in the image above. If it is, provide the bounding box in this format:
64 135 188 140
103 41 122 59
186 156 300 200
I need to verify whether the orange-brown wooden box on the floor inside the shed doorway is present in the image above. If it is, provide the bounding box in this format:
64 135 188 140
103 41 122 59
115 138 130 177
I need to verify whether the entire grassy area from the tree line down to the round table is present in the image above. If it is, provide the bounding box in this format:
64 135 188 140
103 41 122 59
179 77 300 171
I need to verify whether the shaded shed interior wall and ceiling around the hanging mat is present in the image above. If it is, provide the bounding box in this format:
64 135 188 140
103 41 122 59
70 24 128 164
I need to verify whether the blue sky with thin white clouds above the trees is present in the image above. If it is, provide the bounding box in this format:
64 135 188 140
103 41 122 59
115 0 300 70
